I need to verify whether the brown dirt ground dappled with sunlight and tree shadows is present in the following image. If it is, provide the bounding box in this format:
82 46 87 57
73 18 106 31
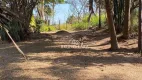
0 30 142 80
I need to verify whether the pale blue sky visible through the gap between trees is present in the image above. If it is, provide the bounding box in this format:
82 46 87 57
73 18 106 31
34 0 89 24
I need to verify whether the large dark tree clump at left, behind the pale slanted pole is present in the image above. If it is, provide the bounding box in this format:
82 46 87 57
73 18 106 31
0 0 38 41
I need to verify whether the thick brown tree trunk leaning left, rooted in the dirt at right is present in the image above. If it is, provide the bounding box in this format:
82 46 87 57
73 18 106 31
105 0 118 50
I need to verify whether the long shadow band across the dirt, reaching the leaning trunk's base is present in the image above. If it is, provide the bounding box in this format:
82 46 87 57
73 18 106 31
0 39 137 54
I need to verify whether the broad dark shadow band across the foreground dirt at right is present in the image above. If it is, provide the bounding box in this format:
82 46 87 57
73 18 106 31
51 54 142 67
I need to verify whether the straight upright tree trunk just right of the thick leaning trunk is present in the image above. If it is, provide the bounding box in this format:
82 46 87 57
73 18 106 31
122 0 131 39
